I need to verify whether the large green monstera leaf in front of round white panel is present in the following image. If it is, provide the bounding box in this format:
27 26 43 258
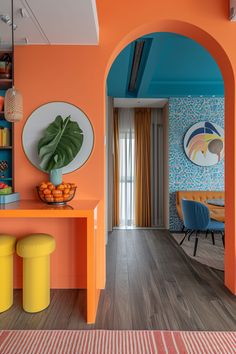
38 116 84 172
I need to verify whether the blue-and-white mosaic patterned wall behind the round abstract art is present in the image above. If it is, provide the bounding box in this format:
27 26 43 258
169 97 224 230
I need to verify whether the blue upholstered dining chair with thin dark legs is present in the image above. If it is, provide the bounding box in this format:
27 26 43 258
180 199 225 256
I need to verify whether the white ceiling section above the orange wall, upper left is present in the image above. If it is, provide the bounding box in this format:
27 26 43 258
0 0 99 47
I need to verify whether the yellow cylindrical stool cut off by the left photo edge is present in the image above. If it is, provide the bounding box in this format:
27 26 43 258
0 235 16 312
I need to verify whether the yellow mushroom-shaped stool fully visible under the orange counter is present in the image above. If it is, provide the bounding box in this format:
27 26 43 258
16 234 55 312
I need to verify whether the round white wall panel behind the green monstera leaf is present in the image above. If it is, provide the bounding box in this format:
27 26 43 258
22 102 94 174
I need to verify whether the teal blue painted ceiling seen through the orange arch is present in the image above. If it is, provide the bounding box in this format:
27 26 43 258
107 33 224 98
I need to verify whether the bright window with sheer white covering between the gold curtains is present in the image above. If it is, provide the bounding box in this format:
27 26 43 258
119 108 135 227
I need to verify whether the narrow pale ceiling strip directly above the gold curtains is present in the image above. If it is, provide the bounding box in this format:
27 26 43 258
114 98 168 108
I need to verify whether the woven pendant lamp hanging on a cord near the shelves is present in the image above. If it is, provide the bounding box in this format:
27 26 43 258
4 0 23 123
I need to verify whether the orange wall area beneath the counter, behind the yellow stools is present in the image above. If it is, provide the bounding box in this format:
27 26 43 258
1 218 86 288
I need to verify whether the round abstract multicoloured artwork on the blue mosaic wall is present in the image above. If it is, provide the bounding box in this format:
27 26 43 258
184 122 224 166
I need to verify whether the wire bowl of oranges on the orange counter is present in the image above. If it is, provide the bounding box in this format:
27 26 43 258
36 182 76 205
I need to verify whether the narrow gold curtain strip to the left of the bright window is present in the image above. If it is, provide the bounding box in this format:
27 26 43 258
113 108 120 226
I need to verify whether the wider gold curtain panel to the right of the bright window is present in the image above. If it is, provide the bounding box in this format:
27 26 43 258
134 108 151 227
